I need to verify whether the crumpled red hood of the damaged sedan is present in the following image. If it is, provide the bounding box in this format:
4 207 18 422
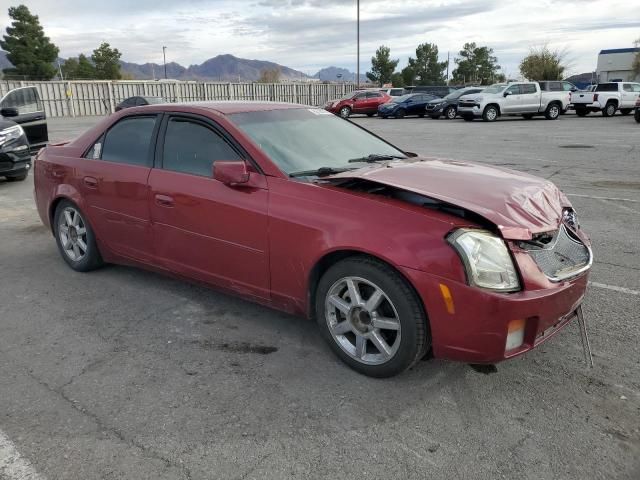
323 157 571 240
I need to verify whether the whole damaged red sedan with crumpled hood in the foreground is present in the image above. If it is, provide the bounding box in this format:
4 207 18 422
34 102 593 377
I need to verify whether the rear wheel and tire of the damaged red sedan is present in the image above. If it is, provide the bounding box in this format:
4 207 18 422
53 200 104 272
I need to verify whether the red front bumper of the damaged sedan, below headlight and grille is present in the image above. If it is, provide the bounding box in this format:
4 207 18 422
403 268 588 363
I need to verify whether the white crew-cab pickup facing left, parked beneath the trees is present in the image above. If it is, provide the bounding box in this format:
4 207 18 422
458 82 570 122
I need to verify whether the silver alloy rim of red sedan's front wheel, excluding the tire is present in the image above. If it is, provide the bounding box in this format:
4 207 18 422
325 277 400 365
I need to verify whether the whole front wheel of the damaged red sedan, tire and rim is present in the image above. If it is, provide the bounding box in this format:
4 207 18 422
315 256 431 378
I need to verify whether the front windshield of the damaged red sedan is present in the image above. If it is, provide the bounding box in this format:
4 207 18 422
229 108 406 174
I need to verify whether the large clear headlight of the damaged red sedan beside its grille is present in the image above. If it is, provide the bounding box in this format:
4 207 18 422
447 228 520 292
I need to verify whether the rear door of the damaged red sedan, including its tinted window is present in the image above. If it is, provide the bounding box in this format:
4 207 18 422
79 115 160 263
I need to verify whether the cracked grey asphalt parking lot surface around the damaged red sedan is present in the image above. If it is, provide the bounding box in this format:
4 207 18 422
0 111 640 480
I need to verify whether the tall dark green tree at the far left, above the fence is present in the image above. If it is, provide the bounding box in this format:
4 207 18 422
0 5 59 80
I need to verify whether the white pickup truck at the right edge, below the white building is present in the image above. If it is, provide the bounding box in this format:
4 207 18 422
571 82 640 117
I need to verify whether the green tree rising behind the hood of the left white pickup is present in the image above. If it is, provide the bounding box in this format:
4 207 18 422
453 43 504 85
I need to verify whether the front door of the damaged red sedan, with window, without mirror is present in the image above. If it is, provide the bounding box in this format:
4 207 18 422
149 115 269 298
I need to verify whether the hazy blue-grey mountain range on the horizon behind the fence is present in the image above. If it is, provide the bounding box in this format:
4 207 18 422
0 50 366 82
